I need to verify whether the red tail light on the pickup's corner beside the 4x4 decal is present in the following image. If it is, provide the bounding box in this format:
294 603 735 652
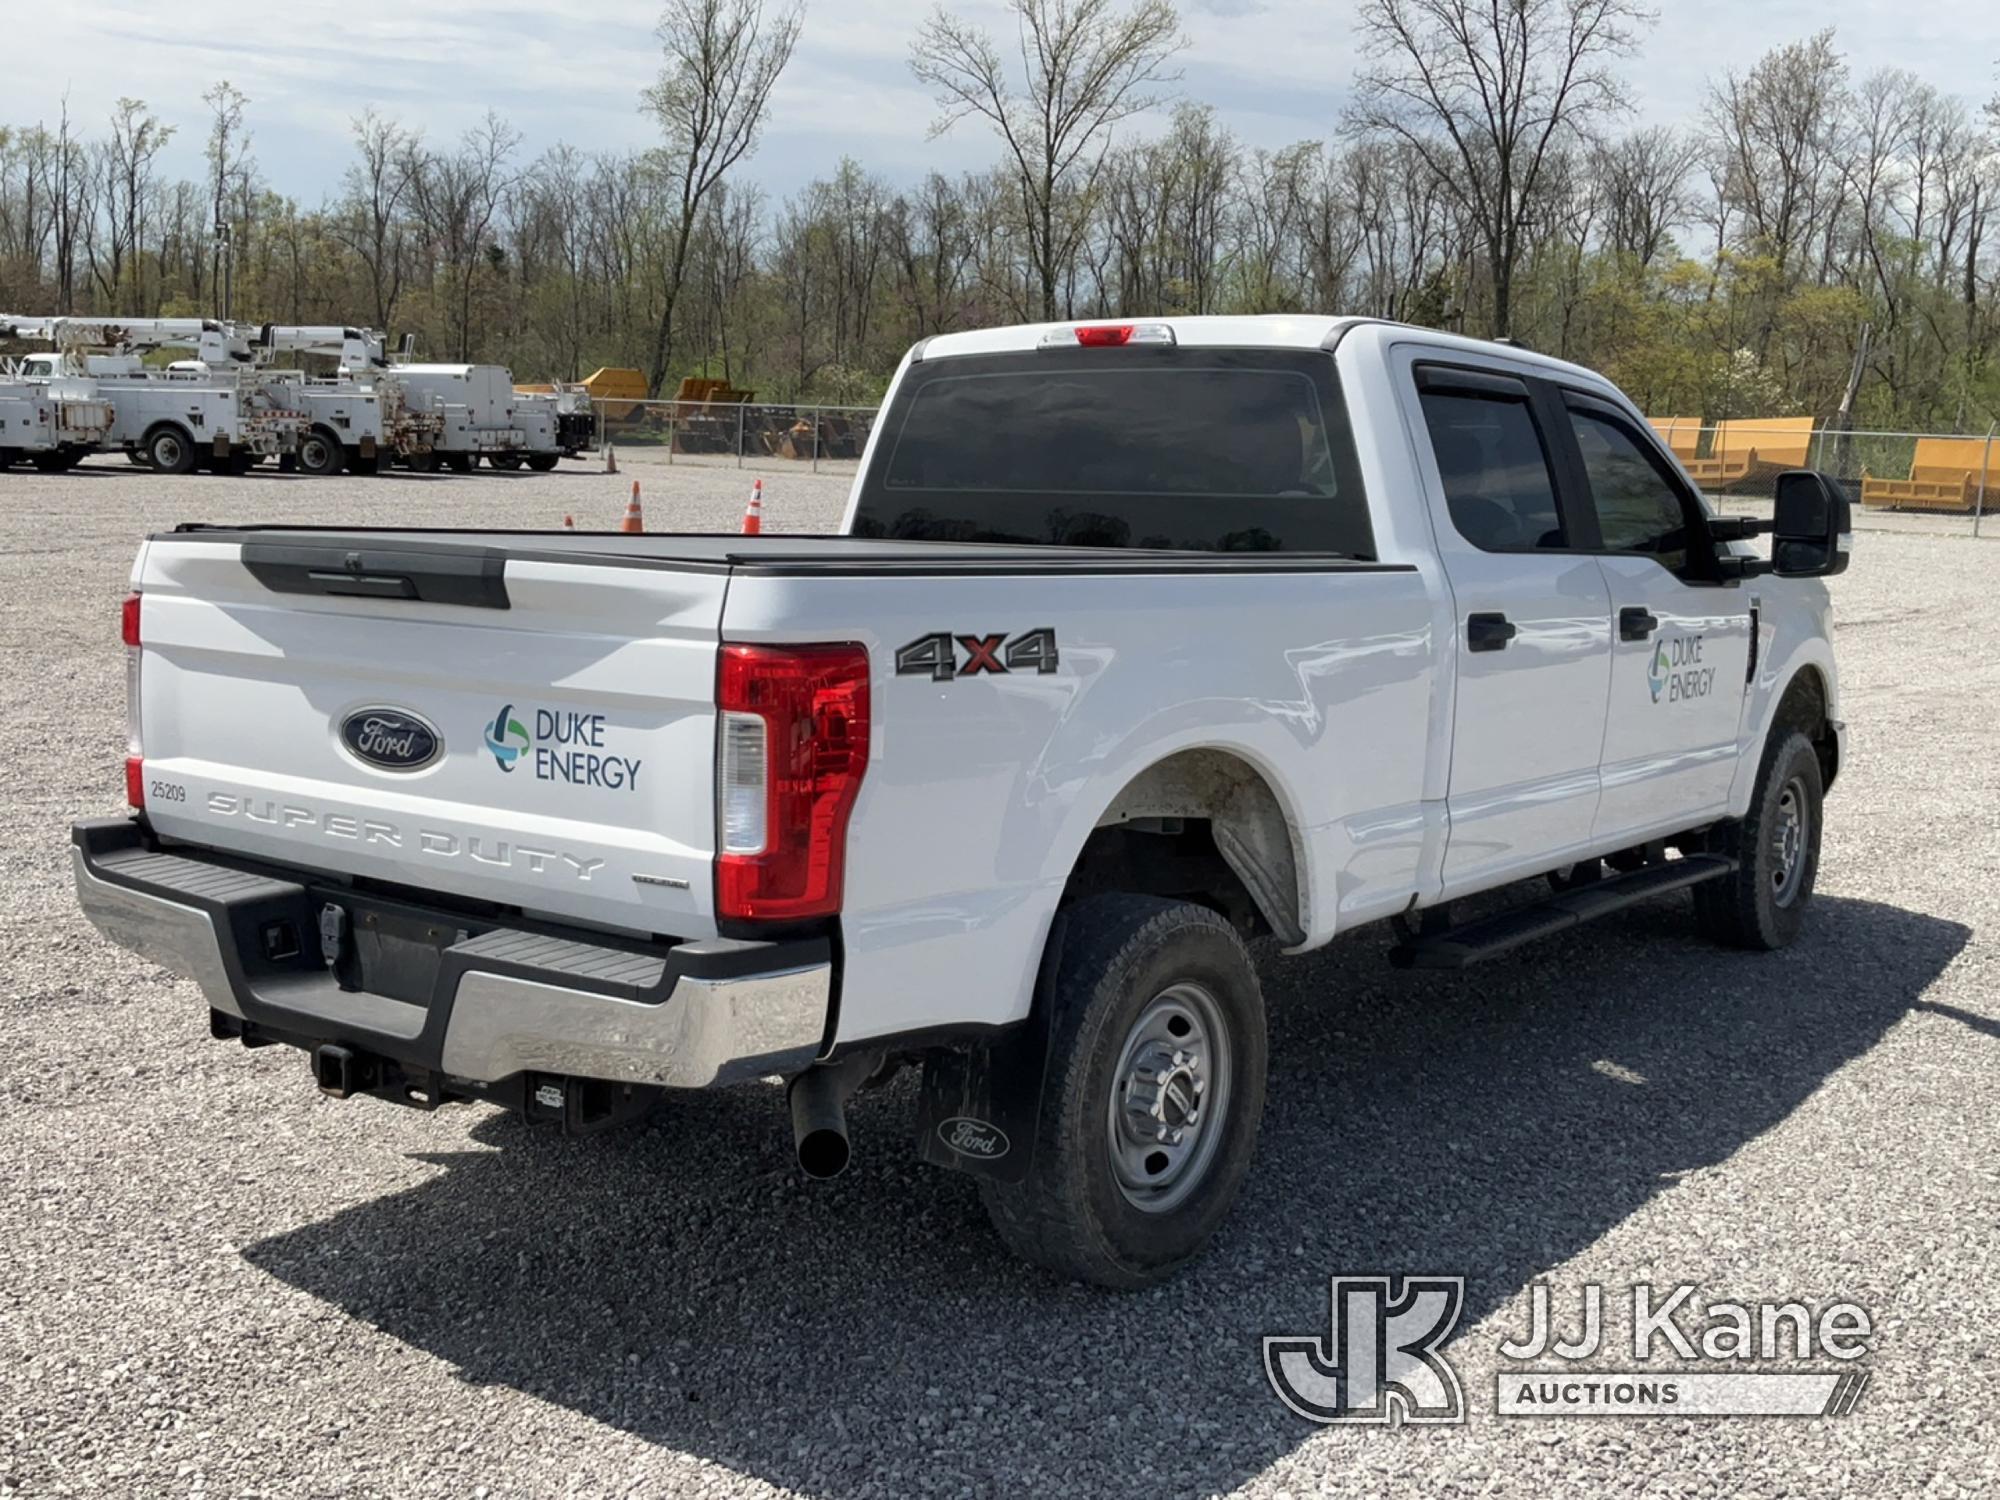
716 646 868 922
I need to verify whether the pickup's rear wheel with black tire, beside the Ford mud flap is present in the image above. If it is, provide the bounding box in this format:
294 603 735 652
980 894 1266 1290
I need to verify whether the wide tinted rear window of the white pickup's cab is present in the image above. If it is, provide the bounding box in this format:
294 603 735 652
854 348 1374 558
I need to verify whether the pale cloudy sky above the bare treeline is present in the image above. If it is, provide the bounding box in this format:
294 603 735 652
0 0 2000 206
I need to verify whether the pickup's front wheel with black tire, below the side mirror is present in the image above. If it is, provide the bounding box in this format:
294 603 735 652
1694 726 1824 952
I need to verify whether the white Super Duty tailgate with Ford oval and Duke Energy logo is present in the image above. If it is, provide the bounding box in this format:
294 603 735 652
138 532 728 936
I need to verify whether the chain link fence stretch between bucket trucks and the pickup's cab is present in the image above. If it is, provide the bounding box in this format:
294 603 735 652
596 400 876 474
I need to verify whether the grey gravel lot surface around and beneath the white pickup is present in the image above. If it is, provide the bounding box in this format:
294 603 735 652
0 462 2000 1500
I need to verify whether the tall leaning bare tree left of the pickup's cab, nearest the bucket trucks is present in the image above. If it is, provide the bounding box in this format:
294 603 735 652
644 0 806 394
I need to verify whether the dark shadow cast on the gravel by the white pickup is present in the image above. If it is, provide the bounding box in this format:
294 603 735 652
244 896 1970 1498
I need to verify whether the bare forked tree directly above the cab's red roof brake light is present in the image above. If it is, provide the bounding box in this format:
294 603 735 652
910 0 1186 318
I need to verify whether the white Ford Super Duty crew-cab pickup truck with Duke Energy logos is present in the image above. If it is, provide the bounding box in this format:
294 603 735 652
74 316 1848 1286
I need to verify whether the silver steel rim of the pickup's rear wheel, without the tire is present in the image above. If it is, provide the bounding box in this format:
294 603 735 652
1106 982 1230 1214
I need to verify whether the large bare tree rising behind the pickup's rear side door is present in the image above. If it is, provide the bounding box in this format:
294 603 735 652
1348 0 1652 338
